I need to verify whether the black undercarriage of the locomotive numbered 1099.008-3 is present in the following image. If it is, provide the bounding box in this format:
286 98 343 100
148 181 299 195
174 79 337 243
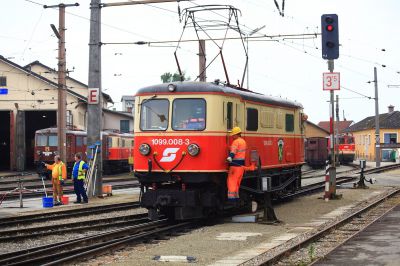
138 166 301 220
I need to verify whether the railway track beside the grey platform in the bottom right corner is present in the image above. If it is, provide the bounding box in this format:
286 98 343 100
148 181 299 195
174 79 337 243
260 188 400 265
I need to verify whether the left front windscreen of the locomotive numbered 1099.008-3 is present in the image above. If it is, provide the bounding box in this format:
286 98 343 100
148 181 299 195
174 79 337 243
140 99 169 131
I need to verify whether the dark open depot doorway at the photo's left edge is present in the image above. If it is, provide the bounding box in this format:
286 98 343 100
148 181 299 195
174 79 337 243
0 111 12 170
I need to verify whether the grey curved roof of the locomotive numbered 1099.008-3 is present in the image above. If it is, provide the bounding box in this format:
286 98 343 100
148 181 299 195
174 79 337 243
136 82 303 108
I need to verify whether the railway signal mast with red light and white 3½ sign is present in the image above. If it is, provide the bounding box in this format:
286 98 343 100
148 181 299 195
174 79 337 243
321 14 340 200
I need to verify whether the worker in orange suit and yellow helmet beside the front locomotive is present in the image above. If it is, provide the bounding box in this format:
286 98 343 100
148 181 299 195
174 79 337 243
226 127 247 200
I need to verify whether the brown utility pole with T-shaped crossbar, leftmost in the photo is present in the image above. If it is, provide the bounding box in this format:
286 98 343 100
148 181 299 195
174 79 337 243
43 3 79 162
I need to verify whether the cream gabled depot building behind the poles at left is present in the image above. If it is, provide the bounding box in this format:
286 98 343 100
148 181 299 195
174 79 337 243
0 55 133 171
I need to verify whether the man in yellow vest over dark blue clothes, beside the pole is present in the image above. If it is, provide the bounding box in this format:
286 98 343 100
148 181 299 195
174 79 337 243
72 153 89 203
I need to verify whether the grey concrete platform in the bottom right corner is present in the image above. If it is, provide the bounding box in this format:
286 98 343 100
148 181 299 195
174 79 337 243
314 206 400 266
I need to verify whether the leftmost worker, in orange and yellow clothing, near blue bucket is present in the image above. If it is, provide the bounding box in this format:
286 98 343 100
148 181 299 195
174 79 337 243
45 155 67 206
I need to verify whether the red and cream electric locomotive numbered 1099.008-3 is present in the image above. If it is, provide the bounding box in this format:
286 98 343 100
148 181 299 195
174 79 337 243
134 82 305 219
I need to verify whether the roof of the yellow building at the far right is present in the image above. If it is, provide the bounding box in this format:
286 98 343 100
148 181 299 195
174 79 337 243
346 111 400 132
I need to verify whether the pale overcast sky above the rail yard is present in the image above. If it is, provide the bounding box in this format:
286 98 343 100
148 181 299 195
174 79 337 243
0 0 400 123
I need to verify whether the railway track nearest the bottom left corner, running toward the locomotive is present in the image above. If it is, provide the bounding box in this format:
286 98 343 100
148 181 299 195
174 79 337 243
0 219 194 265
